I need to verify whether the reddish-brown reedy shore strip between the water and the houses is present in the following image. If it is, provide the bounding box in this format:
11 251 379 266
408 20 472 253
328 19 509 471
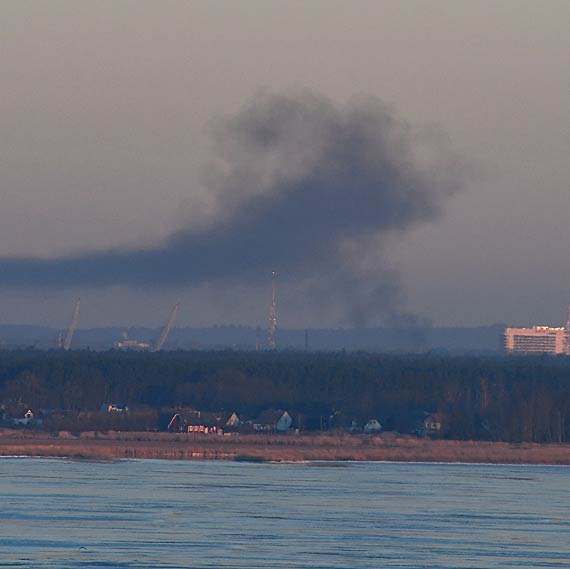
0 429 570 464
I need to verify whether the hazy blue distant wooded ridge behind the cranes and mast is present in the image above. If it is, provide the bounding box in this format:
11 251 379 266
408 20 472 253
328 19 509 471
0 324 505 354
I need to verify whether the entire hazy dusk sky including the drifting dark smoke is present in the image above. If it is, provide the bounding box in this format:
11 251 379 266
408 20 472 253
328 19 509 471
0 0 570 329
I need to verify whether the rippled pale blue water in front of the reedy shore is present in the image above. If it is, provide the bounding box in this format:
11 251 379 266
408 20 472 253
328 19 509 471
0 458 570 569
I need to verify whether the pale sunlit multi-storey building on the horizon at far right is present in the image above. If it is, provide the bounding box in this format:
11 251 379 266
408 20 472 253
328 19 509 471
505 326 568 354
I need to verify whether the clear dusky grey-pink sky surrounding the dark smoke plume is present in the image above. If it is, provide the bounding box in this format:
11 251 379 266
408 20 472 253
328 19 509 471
0 0 570 326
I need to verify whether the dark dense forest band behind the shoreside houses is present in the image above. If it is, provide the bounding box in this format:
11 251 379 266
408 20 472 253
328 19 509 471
0 350 570 442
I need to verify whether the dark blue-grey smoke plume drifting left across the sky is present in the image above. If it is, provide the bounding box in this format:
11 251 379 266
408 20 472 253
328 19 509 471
0 92 458 323
